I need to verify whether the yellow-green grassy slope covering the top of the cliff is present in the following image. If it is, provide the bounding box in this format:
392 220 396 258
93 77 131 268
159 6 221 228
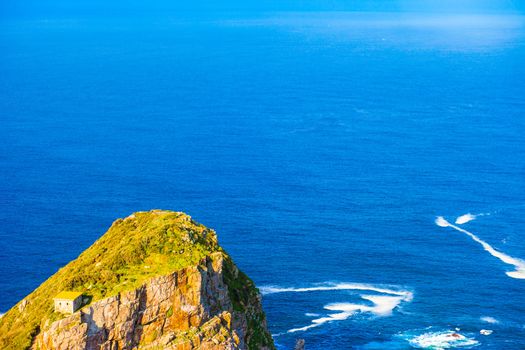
0 210 222 350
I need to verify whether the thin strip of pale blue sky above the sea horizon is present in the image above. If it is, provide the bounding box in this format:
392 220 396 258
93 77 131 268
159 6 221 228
0 0 525 18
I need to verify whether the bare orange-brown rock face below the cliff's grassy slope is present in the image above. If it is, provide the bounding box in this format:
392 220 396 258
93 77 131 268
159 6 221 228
32 253 273 350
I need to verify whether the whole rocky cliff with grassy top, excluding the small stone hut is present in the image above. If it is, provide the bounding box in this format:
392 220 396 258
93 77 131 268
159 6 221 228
0 210 274 350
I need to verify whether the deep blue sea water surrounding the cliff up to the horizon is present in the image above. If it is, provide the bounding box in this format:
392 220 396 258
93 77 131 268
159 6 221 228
0 12 525 349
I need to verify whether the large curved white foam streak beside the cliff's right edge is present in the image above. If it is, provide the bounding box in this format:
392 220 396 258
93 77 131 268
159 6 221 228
266 283 413 333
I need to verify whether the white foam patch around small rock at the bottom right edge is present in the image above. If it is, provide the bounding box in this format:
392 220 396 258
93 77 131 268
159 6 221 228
408 331 479 349
